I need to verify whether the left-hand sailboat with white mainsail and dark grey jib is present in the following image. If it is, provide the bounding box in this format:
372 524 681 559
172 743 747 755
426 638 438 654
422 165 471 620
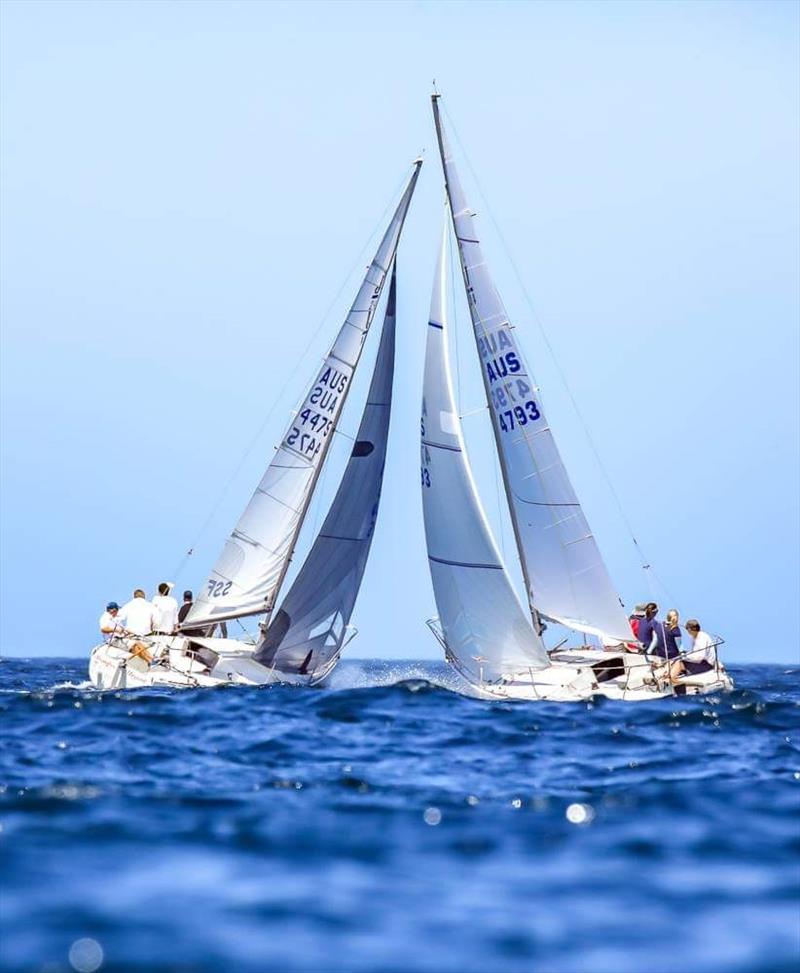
89 159 422 689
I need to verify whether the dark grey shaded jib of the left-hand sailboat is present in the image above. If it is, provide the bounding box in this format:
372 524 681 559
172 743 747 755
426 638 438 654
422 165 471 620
255 269 396 673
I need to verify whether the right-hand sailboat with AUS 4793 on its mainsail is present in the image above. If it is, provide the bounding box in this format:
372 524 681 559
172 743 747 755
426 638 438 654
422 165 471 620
422 94 732 699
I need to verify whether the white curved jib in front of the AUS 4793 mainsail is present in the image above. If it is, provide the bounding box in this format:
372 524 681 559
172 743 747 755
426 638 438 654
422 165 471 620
421 216 549 682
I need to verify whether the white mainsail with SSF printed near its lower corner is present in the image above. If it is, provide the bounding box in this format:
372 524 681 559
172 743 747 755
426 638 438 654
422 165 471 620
184 160 422 627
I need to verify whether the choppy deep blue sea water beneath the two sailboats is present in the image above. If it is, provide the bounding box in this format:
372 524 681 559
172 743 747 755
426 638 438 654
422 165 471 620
0 659 800 973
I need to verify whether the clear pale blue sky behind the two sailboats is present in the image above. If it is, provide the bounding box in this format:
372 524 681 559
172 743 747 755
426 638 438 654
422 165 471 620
0 0 800 662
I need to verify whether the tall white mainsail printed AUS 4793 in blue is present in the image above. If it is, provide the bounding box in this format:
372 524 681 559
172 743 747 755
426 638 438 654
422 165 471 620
432 95 631 641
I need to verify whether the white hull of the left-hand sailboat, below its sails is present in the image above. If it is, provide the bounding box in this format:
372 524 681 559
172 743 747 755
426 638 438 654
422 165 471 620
89 635 322 689
